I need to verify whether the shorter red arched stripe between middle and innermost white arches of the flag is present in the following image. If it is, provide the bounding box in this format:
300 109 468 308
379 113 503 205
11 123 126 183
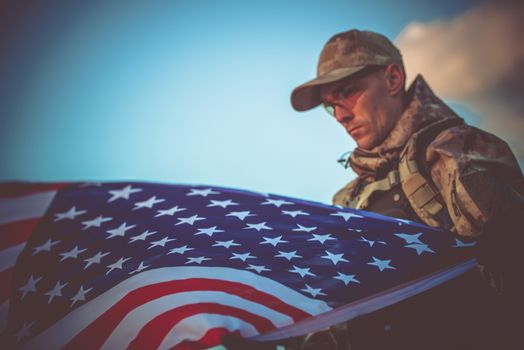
127 303 275 350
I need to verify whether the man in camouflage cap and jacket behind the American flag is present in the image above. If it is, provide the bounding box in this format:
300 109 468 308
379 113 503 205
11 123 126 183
291 30 524 349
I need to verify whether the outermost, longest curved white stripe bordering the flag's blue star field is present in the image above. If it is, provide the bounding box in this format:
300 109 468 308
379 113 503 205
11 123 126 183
23 266 331 349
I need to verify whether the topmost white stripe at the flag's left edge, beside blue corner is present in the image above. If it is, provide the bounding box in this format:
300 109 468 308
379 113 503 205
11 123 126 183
0 191 56 224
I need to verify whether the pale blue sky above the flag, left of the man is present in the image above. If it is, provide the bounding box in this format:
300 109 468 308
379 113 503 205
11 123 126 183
0 1 484 202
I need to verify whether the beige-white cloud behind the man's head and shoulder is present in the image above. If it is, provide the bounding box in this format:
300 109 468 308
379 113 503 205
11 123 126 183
396 0 524 158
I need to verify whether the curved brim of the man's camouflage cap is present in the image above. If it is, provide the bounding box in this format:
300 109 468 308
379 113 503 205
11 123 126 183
291 66 366 111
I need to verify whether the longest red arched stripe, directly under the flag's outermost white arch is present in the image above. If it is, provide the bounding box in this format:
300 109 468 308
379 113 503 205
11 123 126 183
66 278 311 349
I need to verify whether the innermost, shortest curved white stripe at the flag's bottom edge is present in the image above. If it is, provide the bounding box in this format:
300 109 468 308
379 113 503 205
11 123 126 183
158 314 258 350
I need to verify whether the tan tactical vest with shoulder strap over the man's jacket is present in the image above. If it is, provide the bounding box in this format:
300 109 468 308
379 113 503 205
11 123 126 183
335 118 464 231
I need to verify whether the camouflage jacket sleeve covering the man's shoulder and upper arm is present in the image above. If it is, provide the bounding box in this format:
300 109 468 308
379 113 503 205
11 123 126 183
426 125 524 236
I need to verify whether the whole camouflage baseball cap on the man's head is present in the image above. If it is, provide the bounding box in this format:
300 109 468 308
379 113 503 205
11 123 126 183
291 29 402 111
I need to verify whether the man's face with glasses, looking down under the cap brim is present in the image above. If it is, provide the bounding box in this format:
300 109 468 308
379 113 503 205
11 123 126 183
321 69 399 150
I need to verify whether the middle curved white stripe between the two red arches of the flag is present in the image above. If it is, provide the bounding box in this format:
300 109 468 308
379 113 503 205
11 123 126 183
102 292 293 349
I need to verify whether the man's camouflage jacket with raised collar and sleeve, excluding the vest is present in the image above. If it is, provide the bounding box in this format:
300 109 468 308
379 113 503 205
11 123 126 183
333 75 524 236
